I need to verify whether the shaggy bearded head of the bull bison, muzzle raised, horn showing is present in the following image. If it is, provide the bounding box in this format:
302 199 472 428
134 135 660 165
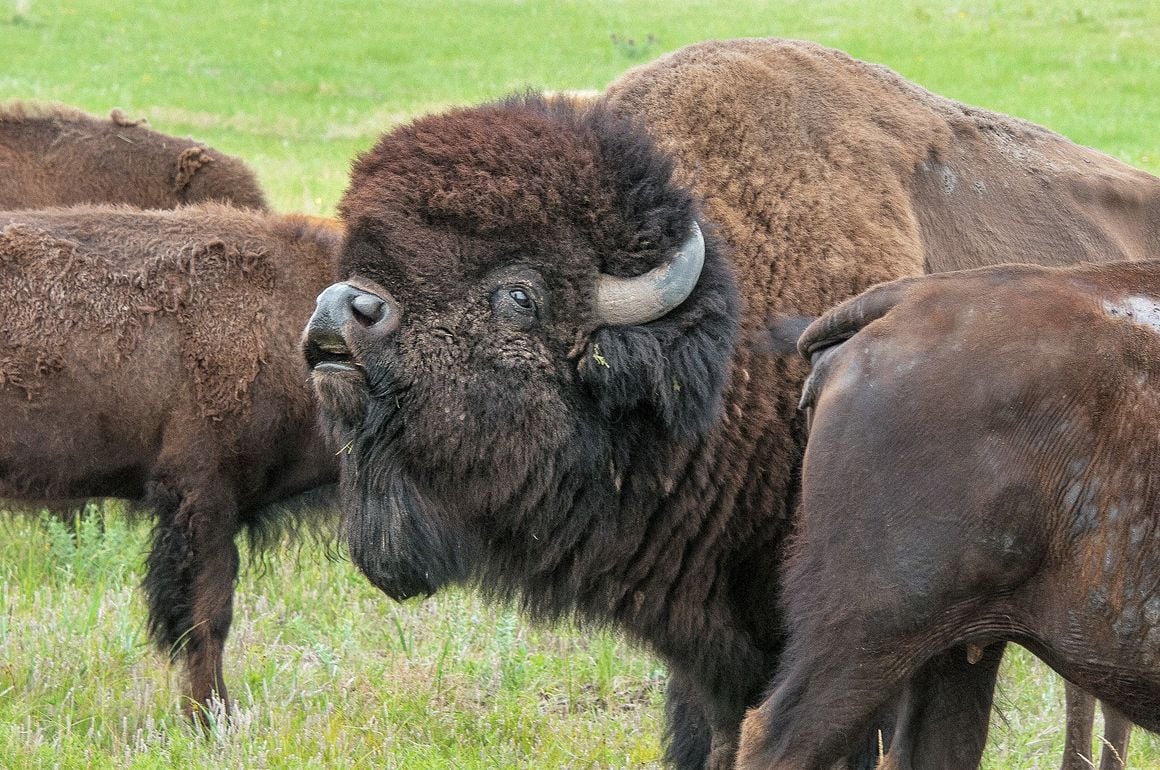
304 96 738 605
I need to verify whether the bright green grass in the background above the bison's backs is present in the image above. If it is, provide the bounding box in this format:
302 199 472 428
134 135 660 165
0 0 1160 213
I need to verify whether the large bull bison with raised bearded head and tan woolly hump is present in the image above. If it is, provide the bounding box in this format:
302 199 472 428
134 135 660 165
304 41 1160 768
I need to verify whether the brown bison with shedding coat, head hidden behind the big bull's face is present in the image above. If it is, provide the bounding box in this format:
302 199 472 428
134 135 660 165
0 204 341 707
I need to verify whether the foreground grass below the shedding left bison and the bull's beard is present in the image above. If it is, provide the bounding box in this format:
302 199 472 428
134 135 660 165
0 510 664 769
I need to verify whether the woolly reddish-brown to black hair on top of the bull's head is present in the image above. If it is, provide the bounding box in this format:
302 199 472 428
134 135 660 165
340 94 693 287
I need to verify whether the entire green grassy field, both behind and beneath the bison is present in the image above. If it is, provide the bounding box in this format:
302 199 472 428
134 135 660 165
0 0 1160 768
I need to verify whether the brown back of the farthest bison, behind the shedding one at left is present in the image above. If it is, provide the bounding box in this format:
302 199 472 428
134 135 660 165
0 102 266 209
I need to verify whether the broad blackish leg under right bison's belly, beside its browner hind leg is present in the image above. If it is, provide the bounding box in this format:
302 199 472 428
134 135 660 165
883 642 1006 770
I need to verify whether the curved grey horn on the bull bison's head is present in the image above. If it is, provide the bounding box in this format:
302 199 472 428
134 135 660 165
593 221 705 326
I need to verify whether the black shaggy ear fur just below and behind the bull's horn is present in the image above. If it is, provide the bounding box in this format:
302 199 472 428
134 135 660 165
577 260 738 440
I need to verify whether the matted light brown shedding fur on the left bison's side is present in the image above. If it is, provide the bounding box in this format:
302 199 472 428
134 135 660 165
0 207 274 420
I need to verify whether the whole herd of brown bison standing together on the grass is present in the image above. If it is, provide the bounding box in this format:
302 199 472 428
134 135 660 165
0 39 1160 770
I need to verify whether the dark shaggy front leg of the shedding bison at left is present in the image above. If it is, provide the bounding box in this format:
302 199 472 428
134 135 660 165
145 477 238 718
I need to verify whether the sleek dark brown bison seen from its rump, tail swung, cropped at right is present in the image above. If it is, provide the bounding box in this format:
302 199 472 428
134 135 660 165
738 262 1160 769
